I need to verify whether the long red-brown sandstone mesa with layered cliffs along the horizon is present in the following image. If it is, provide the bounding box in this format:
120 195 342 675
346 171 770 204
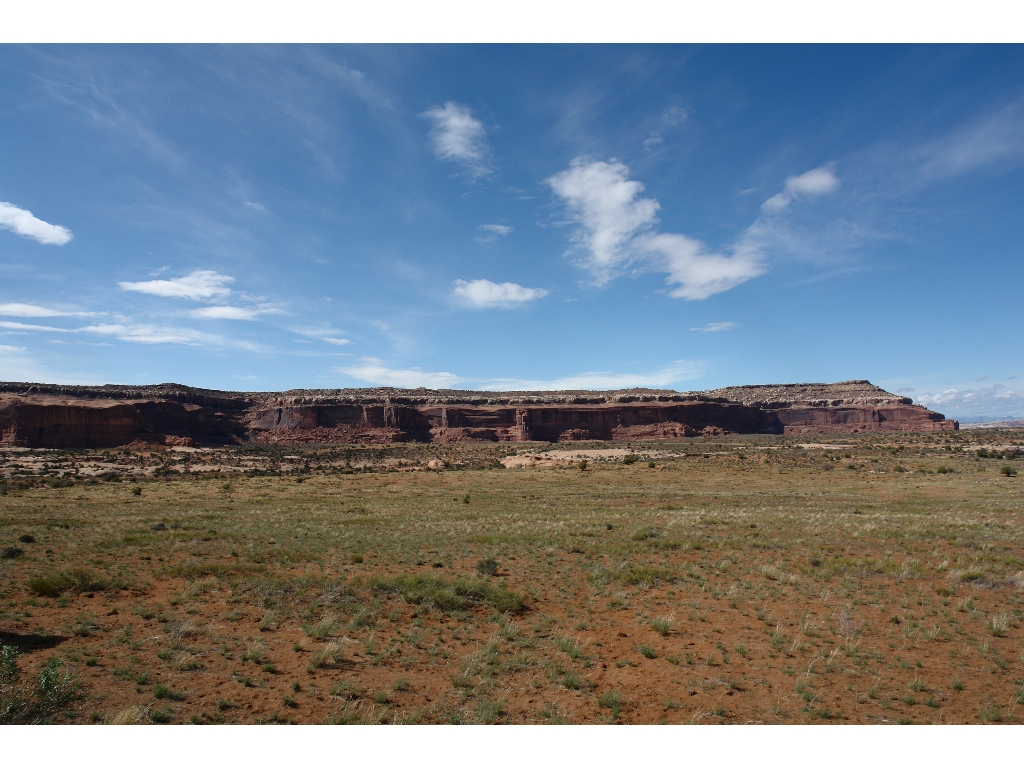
0 381 957 449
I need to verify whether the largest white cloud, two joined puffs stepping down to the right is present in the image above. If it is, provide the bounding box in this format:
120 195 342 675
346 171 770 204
547 159 764 300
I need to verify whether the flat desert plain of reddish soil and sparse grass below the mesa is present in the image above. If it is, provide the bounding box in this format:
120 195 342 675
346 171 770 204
0 430 1024 723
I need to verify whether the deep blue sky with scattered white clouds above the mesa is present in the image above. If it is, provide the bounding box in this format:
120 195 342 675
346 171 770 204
0 45 1024 417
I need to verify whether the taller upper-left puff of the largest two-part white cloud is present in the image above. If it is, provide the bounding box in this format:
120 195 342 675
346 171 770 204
546 158 660 286
